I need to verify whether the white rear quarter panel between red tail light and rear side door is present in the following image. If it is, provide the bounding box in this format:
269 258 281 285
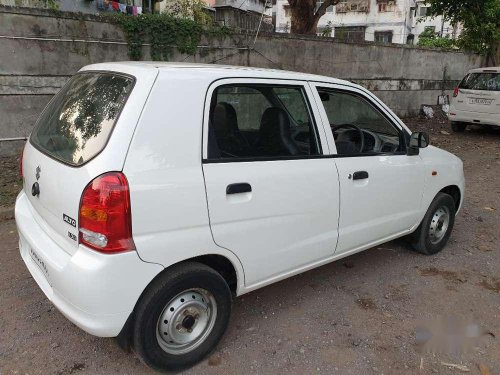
124 69 244 294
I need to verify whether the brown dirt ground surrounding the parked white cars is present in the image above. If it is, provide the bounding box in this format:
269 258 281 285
0 117 500 375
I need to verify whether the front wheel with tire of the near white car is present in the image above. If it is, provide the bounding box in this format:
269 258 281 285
410 193 456 255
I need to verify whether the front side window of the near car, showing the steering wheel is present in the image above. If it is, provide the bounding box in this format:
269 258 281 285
318 88 404 155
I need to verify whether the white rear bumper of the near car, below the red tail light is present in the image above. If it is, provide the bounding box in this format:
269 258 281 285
15 192 163 337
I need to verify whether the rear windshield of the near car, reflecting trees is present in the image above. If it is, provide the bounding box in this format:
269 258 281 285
31 72 134 165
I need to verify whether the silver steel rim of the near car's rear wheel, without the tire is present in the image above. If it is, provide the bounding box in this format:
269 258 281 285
156 289 217 355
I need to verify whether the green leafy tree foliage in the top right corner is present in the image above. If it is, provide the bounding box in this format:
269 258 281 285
428 0 500 65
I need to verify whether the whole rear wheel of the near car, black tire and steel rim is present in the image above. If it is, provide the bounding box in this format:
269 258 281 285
133 262 232 372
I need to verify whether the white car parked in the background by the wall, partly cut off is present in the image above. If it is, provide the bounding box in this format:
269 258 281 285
448 67 500 132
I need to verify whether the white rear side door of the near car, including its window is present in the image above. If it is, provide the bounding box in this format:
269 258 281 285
203 79 339 289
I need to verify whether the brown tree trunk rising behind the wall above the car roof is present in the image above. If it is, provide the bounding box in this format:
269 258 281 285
288 0 340 35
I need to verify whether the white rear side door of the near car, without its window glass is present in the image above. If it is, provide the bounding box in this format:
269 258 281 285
203 79 339 289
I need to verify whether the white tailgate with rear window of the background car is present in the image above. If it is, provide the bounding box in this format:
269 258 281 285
454 69 500 115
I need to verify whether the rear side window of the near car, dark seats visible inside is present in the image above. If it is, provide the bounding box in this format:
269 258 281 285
208 84 320 160
